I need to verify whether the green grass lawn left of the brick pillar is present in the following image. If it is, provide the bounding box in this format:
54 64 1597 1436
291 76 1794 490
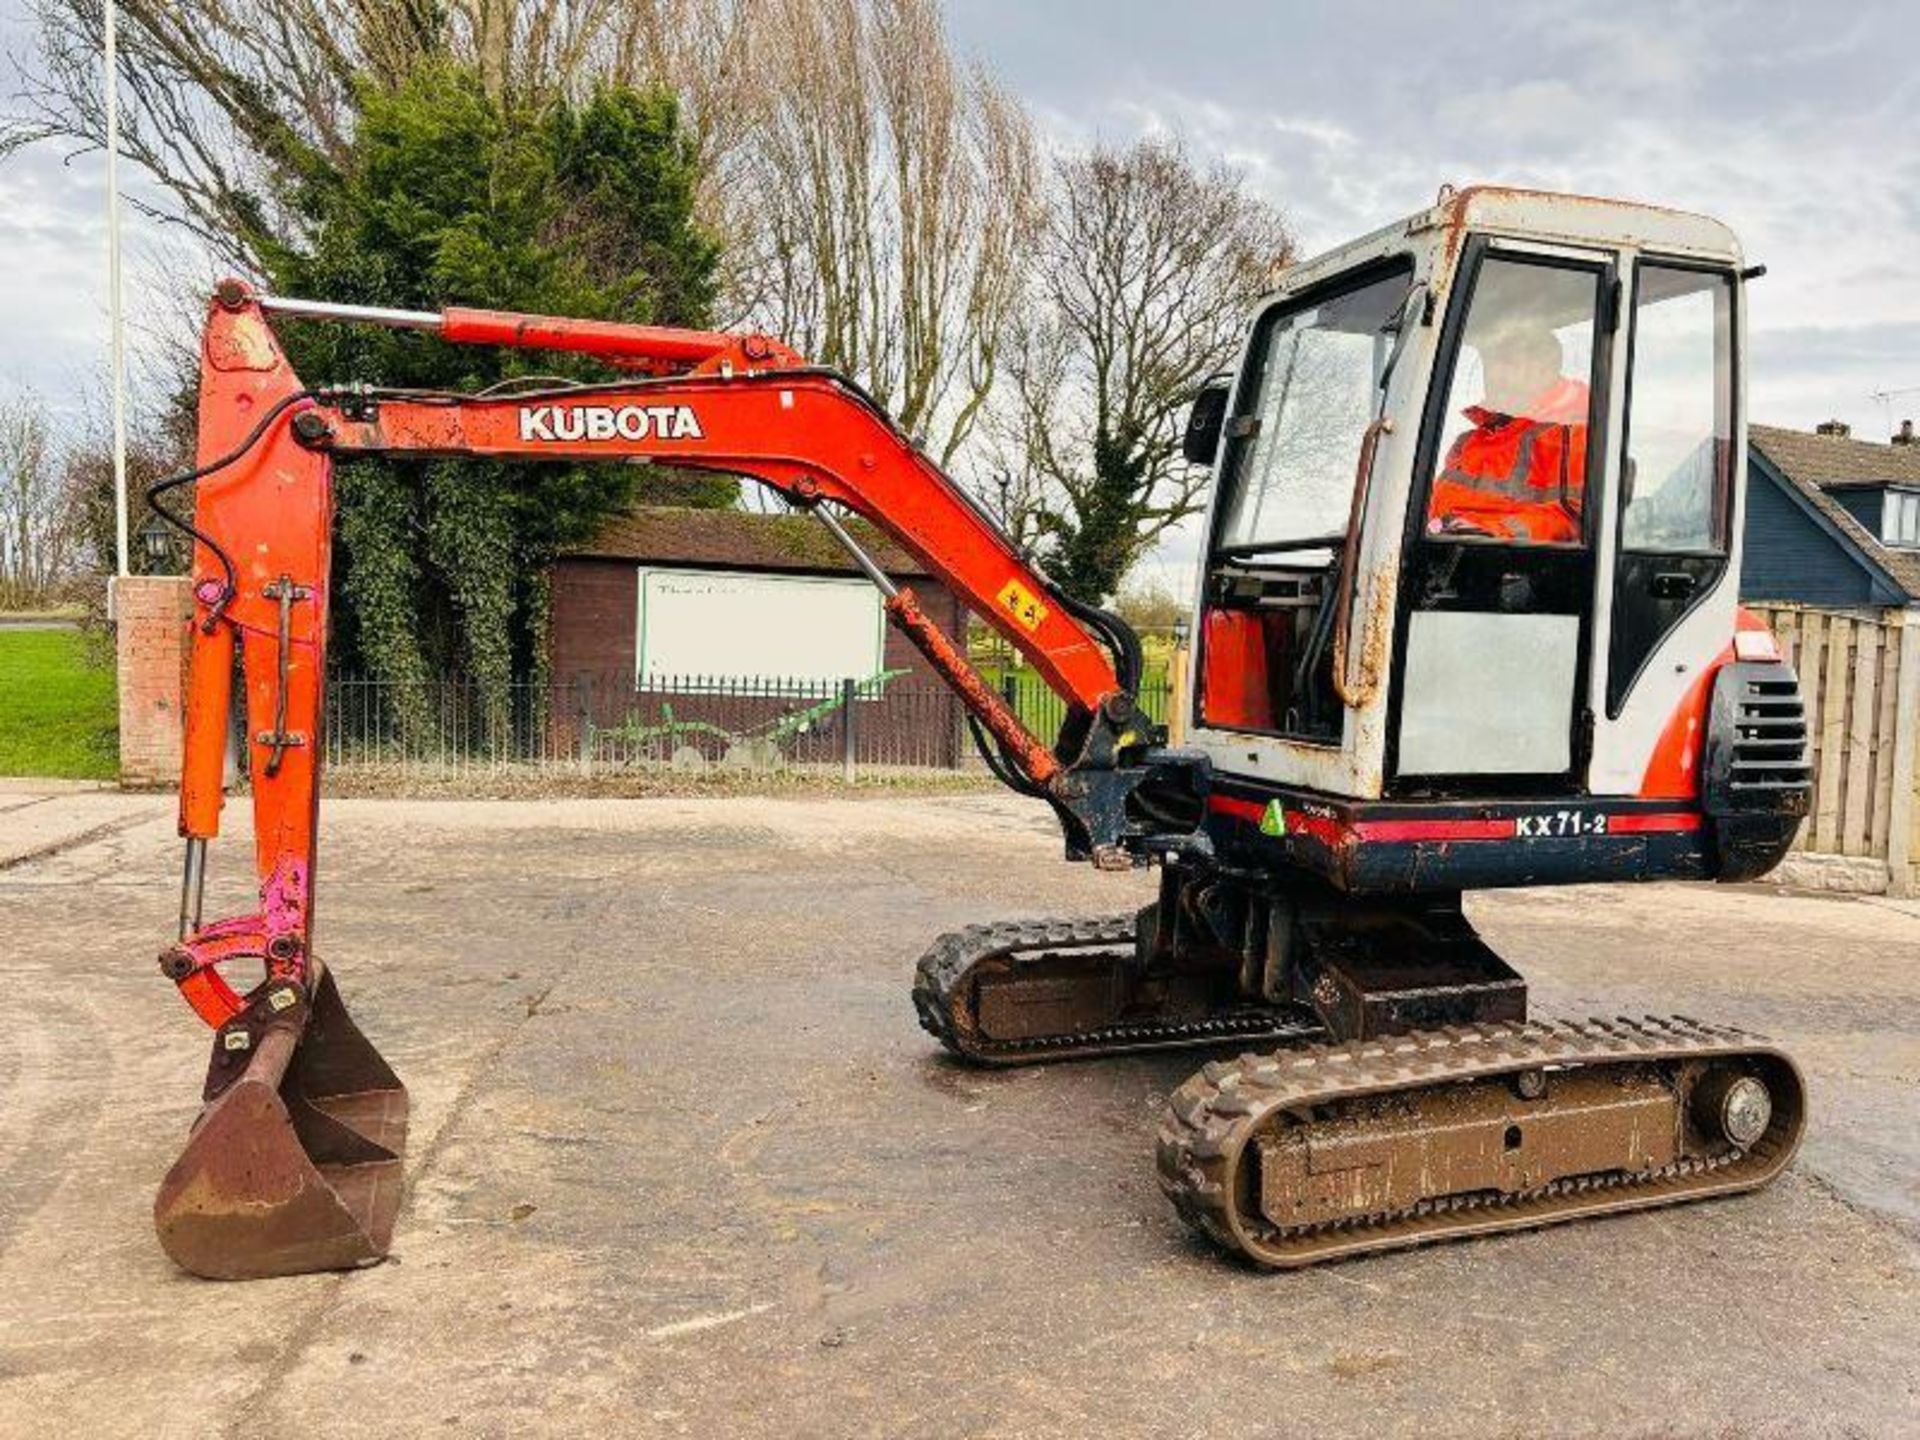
0 630 119 780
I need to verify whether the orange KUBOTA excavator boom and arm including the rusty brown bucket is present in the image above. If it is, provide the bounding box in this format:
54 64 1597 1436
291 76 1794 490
148 282 1208 1279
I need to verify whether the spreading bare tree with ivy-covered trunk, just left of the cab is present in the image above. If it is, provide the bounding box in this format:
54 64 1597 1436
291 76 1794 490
995 138 1294 601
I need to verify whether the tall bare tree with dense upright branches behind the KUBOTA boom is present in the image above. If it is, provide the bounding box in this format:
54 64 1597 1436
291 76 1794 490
733 0 1039 463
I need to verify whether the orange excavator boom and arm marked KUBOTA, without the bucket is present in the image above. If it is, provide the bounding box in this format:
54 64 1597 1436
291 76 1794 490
156 282 1198 1027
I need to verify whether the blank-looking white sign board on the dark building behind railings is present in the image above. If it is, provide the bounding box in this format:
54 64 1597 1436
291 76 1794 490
636 566 887 684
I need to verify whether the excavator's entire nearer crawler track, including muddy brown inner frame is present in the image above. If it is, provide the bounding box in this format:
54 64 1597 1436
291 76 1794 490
1160 1018 1807 1269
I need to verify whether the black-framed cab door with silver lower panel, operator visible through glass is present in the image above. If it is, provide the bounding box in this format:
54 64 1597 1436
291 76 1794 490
1386 236 1619 797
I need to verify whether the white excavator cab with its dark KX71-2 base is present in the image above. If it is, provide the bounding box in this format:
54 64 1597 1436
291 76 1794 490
1188 190 1803 889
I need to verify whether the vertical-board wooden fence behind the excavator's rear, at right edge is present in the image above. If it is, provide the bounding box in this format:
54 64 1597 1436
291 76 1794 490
1749 605 1920 895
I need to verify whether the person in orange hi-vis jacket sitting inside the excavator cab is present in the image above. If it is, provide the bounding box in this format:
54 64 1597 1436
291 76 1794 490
1427 313 1588 545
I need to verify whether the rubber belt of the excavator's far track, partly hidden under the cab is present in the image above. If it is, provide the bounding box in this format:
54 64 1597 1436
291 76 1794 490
914 910 1321 1066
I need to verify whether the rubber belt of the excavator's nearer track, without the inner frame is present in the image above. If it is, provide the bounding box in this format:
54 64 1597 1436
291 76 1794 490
1158 1016 1807 1269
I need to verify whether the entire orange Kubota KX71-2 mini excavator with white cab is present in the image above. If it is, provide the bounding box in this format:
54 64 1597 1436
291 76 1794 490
152 188 1809 1277
